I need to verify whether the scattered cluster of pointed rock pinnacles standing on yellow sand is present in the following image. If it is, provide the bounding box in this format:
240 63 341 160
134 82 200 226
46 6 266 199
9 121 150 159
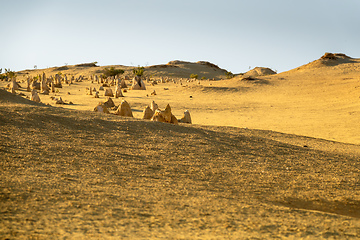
8 73 191 124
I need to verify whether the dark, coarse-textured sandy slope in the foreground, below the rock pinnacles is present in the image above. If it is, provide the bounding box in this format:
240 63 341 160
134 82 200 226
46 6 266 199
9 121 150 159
0 90 360 239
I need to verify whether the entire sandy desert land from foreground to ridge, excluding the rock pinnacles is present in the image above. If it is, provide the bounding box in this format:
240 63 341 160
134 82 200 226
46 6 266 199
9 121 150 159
0 54 360 239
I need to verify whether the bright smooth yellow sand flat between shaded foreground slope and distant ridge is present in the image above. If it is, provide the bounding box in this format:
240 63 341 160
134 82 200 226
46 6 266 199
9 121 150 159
4 60 360 144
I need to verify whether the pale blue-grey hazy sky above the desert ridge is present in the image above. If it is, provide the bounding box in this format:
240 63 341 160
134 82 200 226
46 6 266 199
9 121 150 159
0 0 360 73
